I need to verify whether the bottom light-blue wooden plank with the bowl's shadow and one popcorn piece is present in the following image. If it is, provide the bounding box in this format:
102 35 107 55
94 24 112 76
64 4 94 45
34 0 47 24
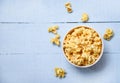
0 53 120 83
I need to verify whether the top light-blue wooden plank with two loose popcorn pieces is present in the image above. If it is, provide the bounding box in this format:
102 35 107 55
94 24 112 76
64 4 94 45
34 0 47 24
0 0 120 22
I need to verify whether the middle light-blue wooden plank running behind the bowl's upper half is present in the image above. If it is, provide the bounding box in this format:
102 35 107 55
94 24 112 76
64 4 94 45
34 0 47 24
0 23 120 54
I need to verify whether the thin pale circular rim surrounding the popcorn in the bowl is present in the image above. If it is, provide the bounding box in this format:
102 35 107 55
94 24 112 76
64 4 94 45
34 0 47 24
62 25 104 68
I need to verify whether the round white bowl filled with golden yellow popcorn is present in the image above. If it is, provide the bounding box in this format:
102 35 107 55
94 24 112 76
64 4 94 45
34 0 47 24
62 26 104 68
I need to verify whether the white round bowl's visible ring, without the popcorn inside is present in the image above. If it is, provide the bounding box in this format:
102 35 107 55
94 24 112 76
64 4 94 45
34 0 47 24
62 26 104 68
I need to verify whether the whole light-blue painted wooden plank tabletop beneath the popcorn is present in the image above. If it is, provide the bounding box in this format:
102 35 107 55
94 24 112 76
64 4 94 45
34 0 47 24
0 0 120 83
